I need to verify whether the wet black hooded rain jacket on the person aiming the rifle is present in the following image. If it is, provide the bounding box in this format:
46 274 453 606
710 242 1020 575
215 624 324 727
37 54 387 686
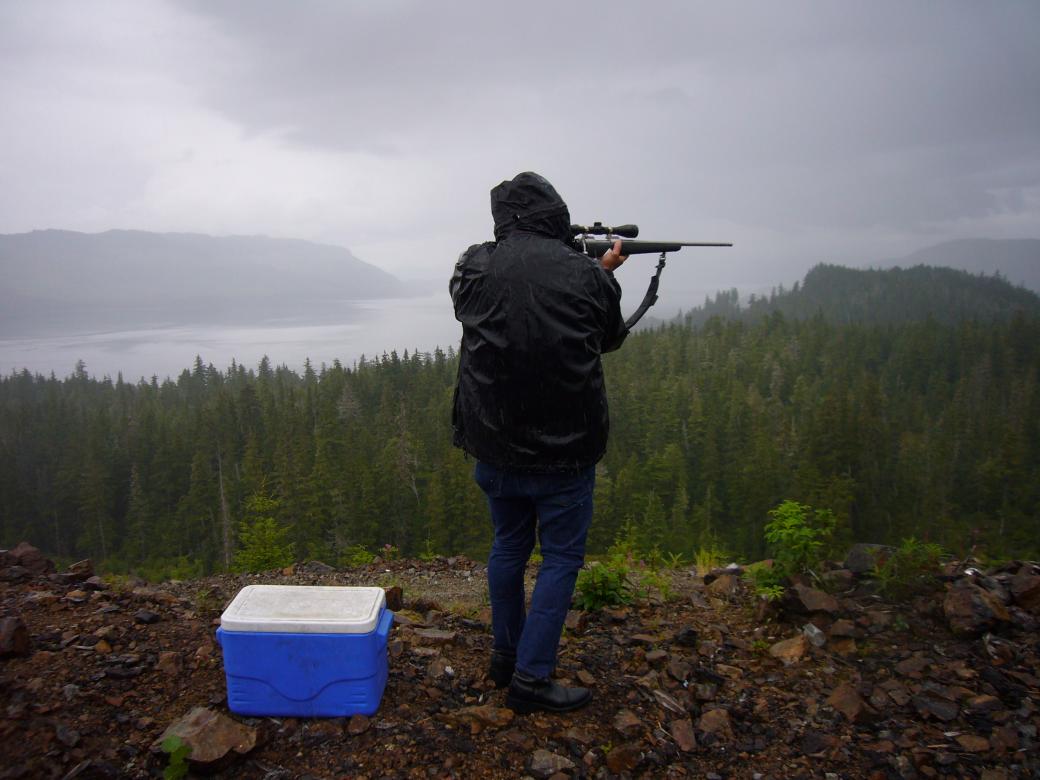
450 174 627 473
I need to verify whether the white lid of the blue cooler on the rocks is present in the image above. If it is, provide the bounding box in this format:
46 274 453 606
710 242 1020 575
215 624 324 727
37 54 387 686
220 586 386 633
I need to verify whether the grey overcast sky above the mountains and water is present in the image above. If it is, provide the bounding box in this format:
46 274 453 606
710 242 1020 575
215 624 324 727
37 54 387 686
0 0 1040 281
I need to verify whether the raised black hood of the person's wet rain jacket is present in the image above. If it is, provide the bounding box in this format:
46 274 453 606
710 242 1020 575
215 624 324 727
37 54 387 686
491 171 572 241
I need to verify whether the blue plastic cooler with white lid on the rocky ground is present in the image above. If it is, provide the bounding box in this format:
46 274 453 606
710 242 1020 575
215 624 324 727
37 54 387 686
216 586 393 718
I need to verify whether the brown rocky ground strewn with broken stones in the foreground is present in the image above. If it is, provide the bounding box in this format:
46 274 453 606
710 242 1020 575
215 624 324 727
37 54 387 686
0 545 1040 780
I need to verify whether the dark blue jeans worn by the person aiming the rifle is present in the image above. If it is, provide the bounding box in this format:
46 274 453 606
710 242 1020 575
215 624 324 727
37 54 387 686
474 463 596 677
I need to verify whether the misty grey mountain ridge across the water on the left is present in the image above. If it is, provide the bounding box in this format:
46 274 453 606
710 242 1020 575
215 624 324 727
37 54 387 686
0 230 408 334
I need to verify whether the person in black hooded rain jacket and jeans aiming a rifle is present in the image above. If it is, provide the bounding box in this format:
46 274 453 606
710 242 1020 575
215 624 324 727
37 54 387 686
450 172 628 712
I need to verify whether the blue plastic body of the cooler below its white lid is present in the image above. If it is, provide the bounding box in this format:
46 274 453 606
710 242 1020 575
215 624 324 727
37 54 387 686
216 609 393 718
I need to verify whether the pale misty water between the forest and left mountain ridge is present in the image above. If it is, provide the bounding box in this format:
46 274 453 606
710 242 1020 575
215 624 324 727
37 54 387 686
0 290 462 382
